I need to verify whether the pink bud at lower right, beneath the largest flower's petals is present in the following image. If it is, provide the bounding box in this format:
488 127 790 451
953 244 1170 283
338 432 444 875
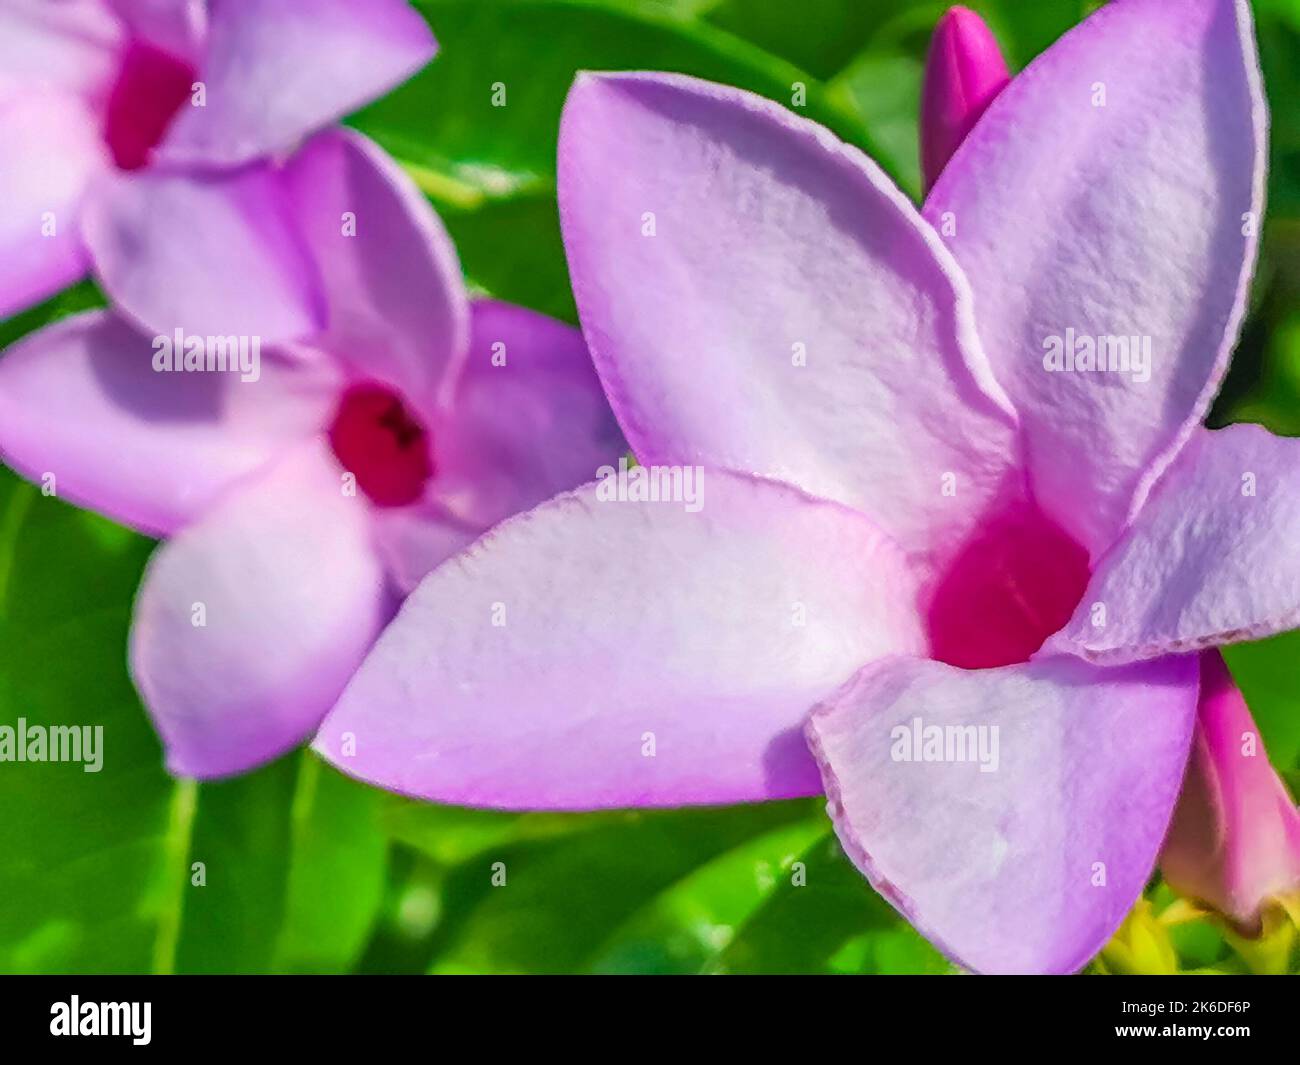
1160 650 1300 935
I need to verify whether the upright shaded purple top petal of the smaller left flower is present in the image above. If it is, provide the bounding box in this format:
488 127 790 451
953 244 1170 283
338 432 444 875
285 130 469 414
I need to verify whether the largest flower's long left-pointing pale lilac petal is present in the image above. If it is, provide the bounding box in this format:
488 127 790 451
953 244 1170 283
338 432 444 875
316 471 924 809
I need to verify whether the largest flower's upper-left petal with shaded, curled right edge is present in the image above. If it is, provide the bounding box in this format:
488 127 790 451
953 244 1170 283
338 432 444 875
559 74 1014 569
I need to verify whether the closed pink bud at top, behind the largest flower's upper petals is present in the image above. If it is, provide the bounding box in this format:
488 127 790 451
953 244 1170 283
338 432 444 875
920 8 1011 190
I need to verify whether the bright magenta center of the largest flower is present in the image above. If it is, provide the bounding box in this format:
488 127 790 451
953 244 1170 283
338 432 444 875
928 506 1091 670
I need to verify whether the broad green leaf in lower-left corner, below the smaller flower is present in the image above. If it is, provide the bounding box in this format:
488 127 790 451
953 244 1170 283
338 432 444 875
0 471 386 973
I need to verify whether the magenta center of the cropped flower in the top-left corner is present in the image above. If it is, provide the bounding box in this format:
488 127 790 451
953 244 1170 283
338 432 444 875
104 42 195 170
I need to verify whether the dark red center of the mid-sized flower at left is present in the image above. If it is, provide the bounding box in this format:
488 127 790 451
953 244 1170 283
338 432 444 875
329 381 433 507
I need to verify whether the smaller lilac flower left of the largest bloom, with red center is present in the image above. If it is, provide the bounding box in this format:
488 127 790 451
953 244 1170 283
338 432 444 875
0 131 625 776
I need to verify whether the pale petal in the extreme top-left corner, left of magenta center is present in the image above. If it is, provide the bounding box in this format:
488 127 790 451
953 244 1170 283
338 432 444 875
0 0 122 98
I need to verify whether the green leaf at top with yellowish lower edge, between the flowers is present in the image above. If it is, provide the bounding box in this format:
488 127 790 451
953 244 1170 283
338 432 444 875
351 0 883 196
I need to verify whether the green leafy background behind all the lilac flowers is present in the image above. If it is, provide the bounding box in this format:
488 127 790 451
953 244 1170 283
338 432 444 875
0 0 1300 973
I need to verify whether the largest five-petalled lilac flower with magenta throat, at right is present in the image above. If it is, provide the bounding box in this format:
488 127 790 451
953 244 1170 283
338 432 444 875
317 0 1279 971
